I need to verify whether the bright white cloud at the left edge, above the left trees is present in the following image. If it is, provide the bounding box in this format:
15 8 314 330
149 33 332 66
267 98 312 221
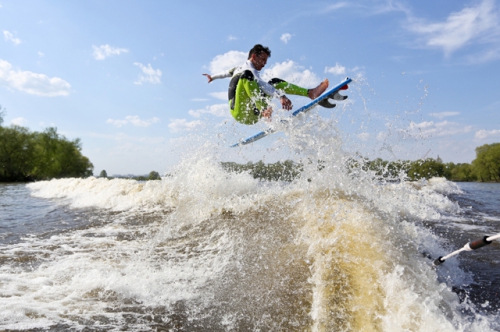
0 59 71 97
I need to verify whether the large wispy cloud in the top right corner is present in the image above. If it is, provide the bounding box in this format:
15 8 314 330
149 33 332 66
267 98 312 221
407 0 500 56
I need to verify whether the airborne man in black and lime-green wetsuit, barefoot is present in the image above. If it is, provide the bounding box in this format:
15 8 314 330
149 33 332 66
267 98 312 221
203 44 329 125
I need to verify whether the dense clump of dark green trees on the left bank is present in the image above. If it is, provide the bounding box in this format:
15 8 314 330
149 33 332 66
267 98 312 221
0 107 94 182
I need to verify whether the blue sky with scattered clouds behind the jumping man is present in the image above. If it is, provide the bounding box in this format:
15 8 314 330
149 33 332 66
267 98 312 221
0 0 500 174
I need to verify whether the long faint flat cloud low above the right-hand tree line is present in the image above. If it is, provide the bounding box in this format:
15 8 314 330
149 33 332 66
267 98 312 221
399 121 472 138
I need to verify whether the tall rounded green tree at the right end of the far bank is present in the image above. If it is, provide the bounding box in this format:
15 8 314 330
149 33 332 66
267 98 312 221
472 143 500 182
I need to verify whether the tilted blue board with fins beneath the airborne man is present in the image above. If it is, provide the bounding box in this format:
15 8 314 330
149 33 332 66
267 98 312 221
231 77 352 148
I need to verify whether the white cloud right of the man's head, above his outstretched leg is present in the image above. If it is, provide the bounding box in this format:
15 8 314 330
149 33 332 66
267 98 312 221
262 60 320 88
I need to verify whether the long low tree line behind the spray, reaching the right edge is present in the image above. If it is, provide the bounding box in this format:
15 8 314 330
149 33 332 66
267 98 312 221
221 143 500 182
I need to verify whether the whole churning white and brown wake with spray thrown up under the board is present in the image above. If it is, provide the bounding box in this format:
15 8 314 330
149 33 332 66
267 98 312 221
0 80 500 331
